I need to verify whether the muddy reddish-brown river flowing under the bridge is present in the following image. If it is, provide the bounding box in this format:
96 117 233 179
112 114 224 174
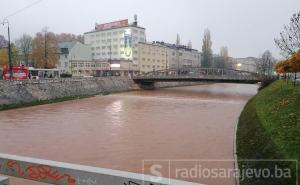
0 84 257 185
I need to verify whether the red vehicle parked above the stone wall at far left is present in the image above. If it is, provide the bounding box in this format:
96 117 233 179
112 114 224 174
3 66 29 80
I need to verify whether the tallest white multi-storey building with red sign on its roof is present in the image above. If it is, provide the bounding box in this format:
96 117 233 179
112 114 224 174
84 16 146 72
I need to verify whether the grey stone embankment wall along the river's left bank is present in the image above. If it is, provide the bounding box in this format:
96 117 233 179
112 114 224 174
0 77 202 106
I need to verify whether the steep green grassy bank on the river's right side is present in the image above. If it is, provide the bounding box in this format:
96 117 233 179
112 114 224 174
237 81 300 185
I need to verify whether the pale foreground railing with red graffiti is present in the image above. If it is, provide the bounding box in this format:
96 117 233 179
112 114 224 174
0 153 200 185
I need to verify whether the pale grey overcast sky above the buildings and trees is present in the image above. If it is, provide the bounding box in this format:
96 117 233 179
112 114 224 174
0 0 300 57
